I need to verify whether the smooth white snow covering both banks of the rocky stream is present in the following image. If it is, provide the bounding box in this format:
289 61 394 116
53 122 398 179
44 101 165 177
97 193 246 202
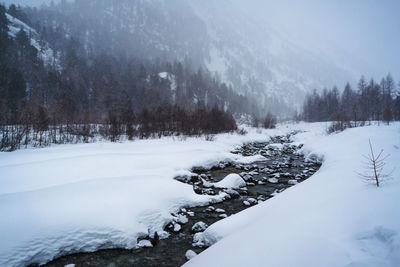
0 123 400 266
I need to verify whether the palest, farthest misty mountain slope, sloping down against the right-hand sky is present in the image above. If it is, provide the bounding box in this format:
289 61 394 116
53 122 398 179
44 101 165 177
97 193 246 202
187 0 354 109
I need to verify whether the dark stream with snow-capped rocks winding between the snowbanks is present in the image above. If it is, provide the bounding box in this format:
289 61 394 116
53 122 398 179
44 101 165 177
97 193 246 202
39 133 321 267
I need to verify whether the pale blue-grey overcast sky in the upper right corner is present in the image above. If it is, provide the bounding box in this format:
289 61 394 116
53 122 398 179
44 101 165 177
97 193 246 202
236 0 400 80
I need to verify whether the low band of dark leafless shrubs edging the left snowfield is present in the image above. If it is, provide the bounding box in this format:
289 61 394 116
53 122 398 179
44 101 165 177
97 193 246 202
0 105 237 151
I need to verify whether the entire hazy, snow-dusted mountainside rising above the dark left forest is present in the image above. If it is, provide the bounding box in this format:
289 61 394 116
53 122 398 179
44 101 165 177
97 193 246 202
5 0 356 115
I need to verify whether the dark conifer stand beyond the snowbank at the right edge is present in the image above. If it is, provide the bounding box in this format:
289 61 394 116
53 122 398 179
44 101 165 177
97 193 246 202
302 74 400 124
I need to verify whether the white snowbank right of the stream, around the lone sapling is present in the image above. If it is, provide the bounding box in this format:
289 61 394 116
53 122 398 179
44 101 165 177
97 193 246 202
185 123 400 267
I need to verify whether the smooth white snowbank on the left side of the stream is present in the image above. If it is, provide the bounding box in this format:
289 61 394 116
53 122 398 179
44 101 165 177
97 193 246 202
0 126 304 267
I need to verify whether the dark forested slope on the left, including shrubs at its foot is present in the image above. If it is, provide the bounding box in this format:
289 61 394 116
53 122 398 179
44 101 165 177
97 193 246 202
0 5 258 150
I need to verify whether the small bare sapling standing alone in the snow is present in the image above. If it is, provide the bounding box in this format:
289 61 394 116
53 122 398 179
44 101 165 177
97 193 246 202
359 140 390 187
